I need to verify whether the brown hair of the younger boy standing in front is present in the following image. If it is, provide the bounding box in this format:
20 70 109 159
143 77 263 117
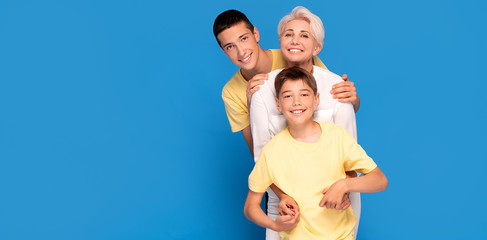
274 67 318 98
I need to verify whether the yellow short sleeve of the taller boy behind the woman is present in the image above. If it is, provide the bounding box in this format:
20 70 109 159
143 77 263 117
222 88 250 132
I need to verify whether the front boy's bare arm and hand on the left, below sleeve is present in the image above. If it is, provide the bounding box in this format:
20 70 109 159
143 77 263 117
244 190 299 232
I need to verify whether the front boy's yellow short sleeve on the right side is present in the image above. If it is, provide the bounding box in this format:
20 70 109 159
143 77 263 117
339 129 377 174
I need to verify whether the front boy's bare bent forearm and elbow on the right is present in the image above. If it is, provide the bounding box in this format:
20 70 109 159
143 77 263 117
344 167 388 193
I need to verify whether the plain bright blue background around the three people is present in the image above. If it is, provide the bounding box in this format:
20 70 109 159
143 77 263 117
0 0 487 239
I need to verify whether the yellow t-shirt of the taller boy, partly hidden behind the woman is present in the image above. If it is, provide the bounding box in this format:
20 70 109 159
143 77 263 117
222 49 327 132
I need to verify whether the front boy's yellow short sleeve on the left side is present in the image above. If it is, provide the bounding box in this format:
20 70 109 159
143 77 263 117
249 152 272 192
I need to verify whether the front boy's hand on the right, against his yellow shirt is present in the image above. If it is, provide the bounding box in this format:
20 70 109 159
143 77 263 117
320 179 350 210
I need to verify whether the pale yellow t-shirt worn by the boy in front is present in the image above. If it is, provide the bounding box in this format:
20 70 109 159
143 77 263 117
249 122 377 240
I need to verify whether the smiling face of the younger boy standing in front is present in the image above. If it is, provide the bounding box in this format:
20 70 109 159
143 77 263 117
276 79 320 124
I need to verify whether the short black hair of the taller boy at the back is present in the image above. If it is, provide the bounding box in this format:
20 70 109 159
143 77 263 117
213 9 254 45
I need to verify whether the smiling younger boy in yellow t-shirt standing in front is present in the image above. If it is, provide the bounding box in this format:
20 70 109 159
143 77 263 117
244 67 387 240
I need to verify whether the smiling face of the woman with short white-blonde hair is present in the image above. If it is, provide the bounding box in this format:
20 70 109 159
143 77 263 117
279 19 321 66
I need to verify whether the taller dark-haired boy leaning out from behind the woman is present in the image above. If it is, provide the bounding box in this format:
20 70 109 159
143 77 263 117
213 10 360 155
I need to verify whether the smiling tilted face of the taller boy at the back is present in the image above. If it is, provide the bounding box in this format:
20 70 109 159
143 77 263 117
217 22 260 70
